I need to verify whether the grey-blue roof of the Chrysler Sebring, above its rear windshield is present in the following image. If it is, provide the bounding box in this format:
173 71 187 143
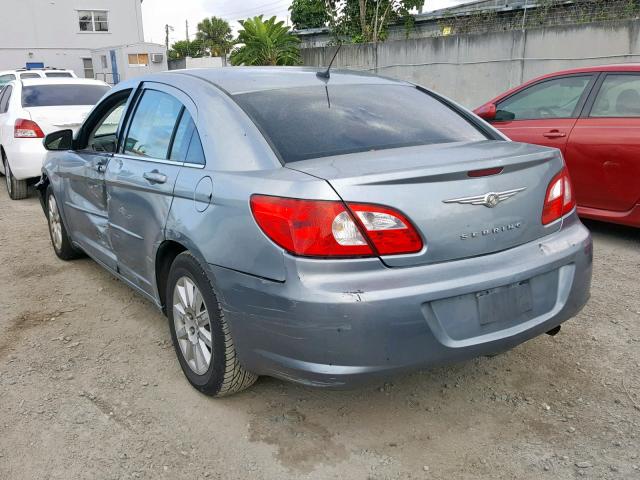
168 67 409 95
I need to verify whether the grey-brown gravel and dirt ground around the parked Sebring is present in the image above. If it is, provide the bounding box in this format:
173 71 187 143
0 185 640 479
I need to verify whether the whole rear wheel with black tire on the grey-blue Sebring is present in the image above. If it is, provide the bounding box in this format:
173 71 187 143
165 252 258 397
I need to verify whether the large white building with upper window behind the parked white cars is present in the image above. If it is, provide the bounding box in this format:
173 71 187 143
0 0 150 80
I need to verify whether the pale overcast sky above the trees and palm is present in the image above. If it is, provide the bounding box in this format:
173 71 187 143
142 0 469 43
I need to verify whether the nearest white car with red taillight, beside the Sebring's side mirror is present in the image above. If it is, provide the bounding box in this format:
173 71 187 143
0 78 111 200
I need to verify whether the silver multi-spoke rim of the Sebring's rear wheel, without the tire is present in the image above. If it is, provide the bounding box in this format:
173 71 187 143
173 276 213 375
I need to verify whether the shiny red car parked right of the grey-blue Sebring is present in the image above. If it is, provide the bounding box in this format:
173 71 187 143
475 64 640 227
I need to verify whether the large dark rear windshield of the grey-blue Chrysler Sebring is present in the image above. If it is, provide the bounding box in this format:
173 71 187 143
234 85 487 163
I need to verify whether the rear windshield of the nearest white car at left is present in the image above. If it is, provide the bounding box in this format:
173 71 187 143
22 84 109 108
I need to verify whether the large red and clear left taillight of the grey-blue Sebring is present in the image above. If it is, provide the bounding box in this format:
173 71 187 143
251 195 422 257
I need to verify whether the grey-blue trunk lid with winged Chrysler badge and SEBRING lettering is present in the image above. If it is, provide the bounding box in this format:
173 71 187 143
287 141 563 267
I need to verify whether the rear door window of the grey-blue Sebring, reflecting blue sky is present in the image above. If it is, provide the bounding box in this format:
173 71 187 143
124 90 182 159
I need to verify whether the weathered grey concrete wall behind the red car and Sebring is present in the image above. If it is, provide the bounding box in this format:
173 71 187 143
301 20 640 108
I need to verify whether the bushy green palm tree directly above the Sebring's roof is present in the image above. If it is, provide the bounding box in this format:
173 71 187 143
231 15 301 65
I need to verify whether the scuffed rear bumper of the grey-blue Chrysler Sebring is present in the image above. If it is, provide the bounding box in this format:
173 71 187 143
211 214 592 387
